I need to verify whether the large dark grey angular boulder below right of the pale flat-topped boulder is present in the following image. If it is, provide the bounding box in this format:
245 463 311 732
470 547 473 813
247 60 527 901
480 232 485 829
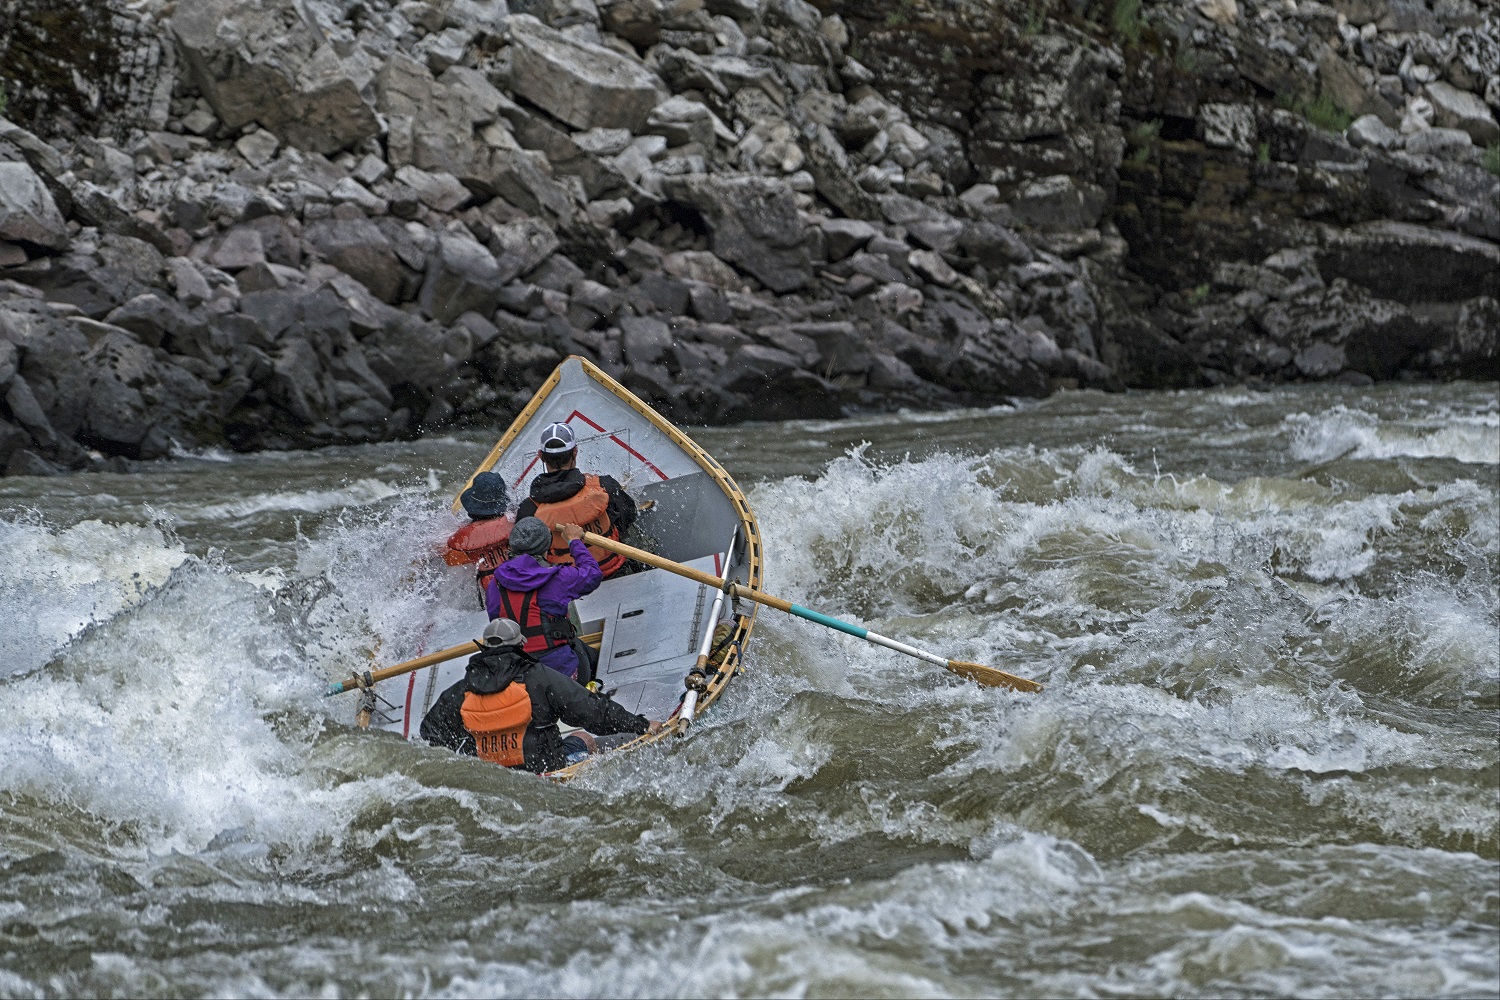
663 177 813 292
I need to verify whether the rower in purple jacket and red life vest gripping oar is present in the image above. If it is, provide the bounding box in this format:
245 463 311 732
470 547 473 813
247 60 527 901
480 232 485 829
485 517 605 684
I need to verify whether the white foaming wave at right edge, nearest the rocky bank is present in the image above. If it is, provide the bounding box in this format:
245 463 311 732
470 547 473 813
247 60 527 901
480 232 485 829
1284 405 1500 465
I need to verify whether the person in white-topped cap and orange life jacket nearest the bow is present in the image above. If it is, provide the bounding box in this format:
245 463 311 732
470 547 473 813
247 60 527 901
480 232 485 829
516 424 636 579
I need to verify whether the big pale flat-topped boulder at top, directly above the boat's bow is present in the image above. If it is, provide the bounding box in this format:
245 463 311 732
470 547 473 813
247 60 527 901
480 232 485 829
510 15 665 132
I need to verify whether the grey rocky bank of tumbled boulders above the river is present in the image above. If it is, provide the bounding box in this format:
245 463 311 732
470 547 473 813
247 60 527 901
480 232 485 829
0 0 1500 474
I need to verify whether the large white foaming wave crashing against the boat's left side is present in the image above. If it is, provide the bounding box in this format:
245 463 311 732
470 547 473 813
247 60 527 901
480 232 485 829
0 501 489 858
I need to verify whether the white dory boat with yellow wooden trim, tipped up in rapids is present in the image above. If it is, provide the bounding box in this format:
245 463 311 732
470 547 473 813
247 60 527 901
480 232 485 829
372 355 762 778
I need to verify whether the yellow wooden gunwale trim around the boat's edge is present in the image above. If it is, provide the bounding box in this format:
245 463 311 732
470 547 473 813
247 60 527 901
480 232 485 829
453 354 765 781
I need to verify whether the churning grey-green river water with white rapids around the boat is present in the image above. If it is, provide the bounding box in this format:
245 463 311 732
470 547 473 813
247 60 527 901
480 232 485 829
0 384 1500 997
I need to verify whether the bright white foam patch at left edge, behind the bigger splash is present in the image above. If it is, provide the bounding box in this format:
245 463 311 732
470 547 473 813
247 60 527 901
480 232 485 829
0 520 188 676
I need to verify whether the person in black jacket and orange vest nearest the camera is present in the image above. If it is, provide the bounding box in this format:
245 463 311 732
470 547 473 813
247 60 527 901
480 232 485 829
422 618 662 774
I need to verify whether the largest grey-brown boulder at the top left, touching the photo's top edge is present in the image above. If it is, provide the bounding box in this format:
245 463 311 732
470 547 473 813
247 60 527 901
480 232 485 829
171 0 380 153
